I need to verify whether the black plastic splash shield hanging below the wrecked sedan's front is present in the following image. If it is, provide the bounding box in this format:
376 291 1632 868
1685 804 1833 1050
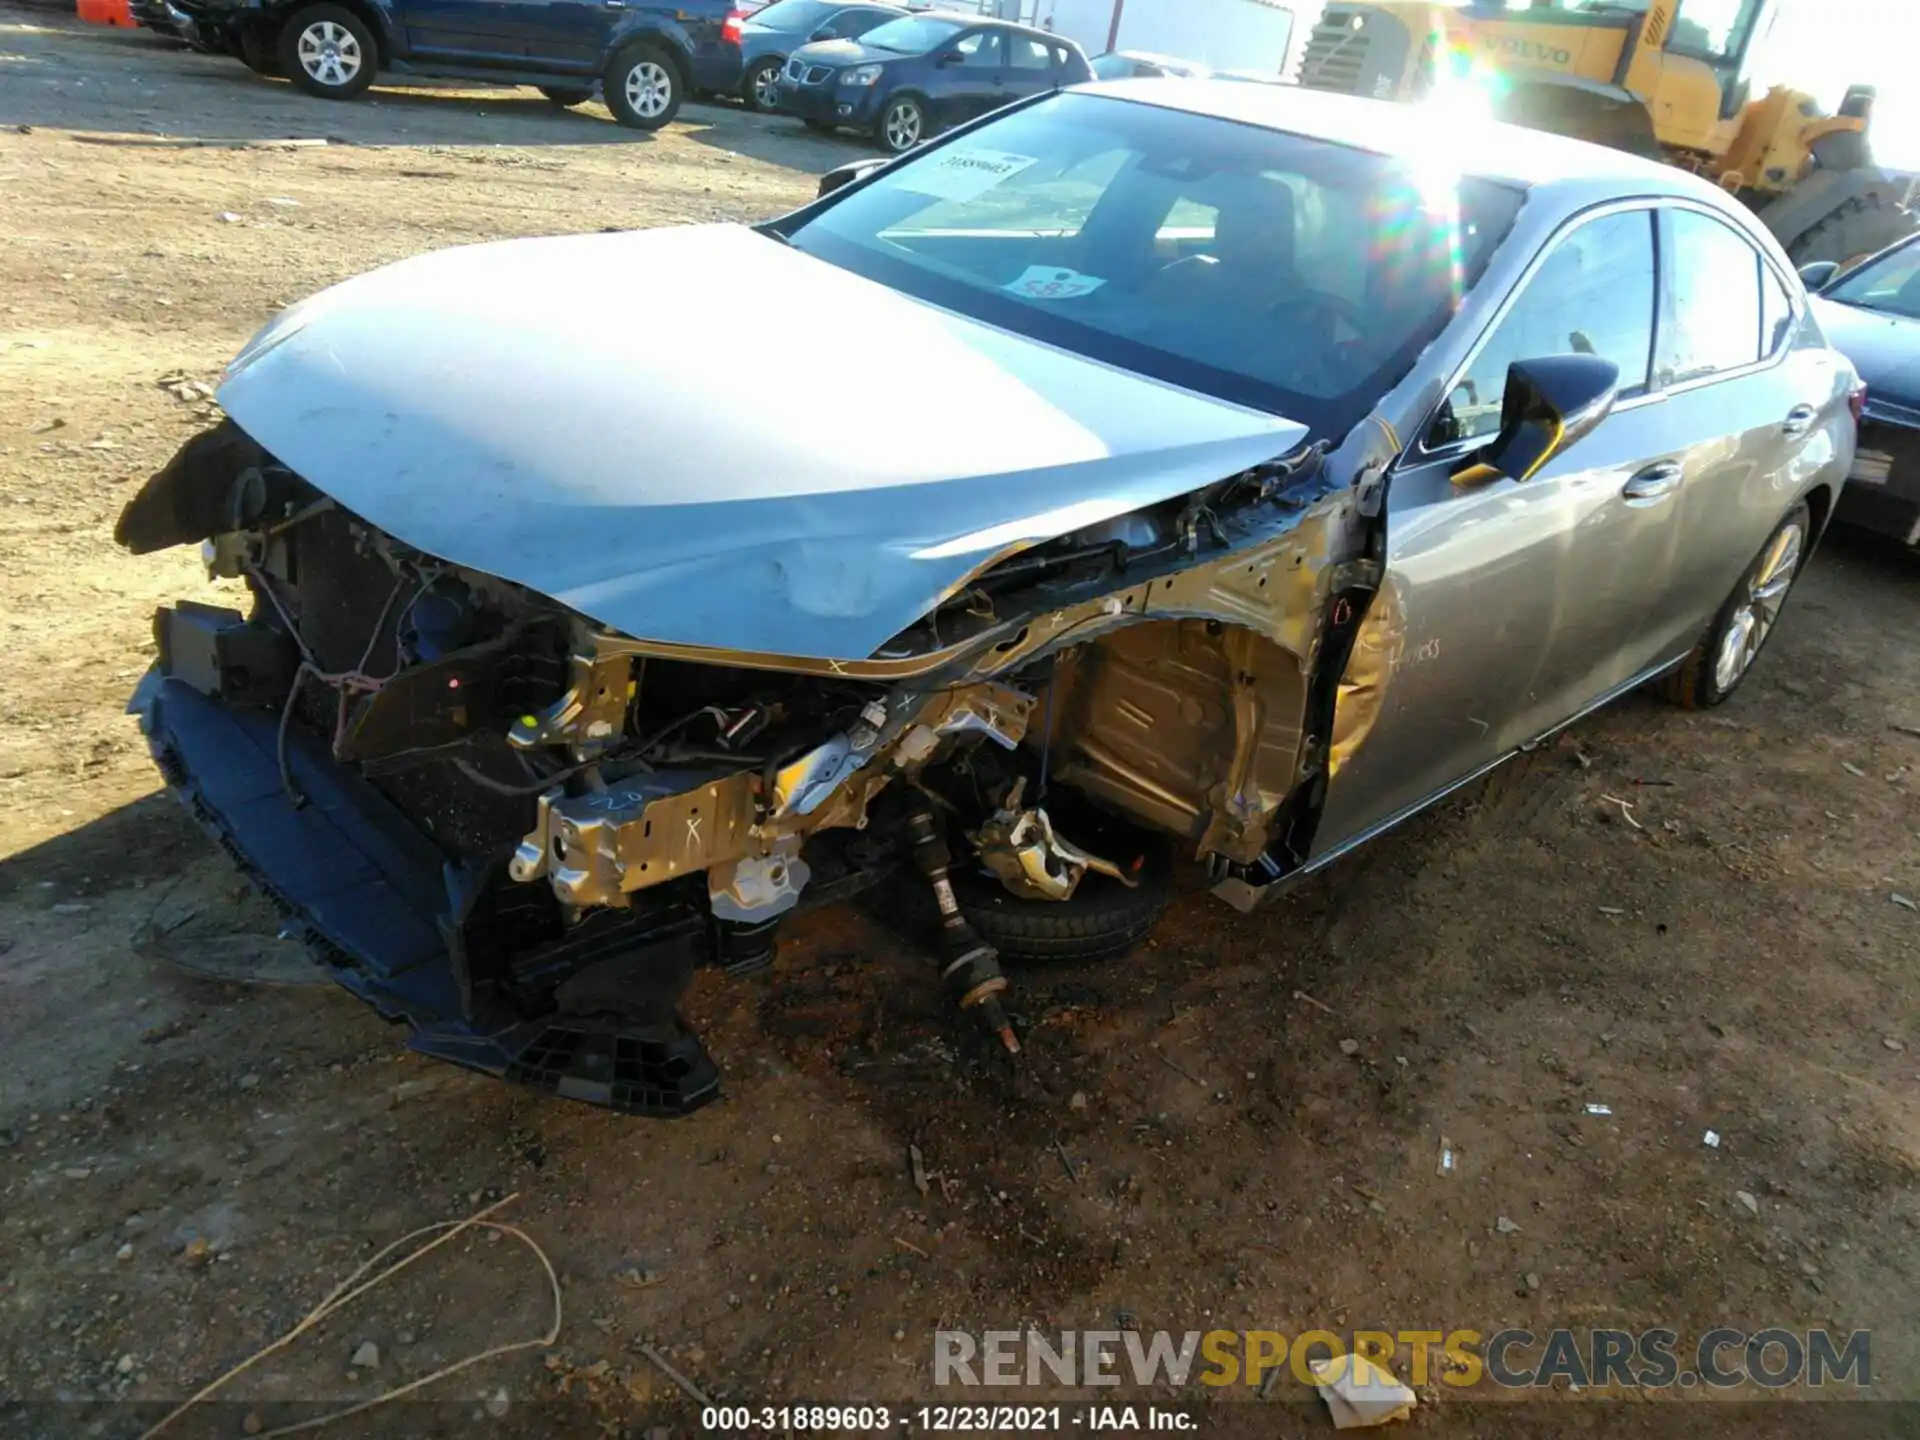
127 672 720 1117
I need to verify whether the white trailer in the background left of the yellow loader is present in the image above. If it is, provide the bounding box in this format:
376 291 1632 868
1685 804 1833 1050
939 0 1294 79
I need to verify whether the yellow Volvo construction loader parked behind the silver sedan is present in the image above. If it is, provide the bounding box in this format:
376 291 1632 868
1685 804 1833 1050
1300 0 1920 265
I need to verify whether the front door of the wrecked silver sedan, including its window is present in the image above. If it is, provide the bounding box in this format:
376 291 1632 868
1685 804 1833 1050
1315 202 1678 851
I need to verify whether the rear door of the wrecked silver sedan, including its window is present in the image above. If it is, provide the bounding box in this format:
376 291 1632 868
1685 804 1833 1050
1655 205 1843 629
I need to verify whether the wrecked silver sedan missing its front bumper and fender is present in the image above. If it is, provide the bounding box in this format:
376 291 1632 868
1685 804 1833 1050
119 83 1855 1116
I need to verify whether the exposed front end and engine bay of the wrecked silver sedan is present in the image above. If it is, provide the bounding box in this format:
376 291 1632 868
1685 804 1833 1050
117 422 1384 1114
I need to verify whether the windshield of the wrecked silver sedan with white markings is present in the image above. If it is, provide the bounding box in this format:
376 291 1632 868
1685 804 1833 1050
789 94 1521 434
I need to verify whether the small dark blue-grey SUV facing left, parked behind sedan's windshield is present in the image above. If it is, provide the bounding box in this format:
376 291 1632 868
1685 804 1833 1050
774 13 1092 156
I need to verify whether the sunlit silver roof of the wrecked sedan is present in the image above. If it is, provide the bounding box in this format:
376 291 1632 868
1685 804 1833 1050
1075 79 1740 204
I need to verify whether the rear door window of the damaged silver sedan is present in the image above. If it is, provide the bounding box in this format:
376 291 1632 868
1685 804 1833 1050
1655 209 1763 388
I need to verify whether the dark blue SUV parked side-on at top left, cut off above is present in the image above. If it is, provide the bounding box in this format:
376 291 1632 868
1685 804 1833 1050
175 0 747 131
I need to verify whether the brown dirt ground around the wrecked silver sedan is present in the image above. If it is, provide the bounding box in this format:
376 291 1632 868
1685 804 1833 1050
0 10 1920 1436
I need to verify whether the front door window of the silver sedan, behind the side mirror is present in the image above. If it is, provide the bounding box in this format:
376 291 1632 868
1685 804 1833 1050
1427 209 1655 445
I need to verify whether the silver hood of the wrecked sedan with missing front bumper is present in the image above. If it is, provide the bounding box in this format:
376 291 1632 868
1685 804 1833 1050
219 225 1306 659
